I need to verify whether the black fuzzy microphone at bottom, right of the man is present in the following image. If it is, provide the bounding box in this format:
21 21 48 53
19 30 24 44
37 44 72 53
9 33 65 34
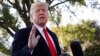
70 41 84 56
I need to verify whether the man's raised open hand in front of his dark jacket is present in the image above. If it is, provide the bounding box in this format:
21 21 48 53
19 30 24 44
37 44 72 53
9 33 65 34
28 25 40 49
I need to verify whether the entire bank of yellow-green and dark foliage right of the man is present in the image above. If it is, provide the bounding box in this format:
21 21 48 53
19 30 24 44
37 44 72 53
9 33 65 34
52 20 100 56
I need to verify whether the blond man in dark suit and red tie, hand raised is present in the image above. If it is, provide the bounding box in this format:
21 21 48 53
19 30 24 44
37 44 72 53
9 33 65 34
12 2 61 56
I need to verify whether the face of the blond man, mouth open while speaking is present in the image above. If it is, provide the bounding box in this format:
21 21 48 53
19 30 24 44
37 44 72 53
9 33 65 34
32 5 48 26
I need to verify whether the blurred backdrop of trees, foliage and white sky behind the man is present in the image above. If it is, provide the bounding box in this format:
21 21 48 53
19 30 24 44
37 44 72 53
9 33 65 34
0 0 100 56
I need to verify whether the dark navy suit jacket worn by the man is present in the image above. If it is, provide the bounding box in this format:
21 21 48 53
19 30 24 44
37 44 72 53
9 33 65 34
12 26 61 56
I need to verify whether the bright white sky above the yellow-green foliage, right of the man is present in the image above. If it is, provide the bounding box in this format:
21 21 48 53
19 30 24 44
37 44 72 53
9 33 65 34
58 0 100 25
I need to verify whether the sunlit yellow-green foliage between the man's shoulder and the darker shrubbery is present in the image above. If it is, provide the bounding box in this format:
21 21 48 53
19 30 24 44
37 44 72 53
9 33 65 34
52 22 95 49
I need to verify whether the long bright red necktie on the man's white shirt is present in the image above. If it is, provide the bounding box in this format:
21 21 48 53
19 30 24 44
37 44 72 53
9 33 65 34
43 29 57 56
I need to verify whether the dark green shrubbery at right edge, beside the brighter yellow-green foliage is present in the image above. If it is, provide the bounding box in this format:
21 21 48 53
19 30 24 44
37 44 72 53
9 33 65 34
84 22 100 56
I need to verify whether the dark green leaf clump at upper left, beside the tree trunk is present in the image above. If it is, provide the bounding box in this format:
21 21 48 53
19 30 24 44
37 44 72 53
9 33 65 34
2 5 16 28
